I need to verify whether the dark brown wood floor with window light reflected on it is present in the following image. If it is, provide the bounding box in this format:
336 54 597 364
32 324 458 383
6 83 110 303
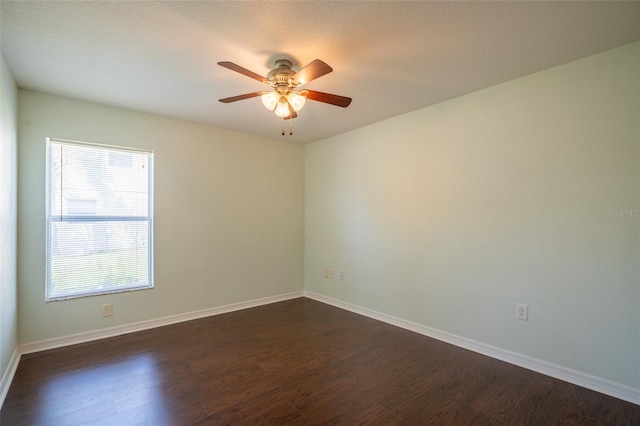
0 298 640 426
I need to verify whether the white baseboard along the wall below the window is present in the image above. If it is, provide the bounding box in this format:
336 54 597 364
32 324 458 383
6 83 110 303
20 291 304 354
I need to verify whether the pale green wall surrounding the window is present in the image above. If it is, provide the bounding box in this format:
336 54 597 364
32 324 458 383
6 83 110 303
18 90 304 343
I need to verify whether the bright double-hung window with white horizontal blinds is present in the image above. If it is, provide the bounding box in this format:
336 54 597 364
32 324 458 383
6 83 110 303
46 139 153 300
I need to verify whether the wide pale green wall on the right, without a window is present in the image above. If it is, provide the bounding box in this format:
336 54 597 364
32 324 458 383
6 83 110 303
305 43 640 389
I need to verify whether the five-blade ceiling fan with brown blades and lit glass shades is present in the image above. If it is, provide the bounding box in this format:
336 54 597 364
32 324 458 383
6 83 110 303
218 59 351 135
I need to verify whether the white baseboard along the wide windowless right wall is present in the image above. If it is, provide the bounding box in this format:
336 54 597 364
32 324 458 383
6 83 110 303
304 290 640 405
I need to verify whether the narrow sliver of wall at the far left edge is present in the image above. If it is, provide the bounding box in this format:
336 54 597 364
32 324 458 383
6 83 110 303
0 55 18 392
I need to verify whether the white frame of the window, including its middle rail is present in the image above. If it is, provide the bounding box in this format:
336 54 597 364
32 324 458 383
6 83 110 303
45 137 155 302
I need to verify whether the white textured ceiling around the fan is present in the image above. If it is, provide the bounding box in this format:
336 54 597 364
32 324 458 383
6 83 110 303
0 0 640 142
